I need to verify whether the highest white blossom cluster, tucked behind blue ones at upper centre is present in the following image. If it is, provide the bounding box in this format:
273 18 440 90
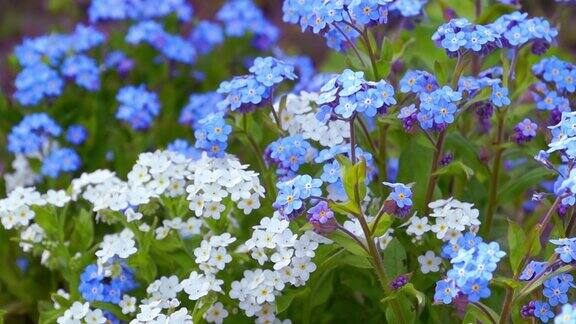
274 91 350 147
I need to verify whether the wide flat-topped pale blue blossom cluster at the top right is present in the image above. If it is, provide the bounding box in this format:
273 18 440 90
432 12 558 56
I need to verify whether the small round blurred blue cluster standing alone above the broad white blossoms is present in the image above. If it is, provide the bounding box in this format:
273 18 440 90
116 84 160 131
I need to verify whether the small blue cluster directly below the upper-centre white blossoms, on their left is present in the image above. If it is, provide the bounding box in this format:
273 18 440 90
264 135 316 179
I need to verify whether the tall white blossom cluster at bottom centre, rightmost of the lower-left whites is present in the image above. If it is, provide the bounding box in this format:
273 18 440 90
230 212 331 323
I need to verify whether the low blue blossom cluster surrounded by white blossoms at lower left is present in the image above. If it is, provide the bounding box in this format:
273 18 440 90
78 263 138 305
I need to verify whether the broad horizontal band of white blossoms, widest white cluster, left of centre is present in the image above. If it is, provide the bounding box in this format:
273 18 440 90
72 151 264 219
